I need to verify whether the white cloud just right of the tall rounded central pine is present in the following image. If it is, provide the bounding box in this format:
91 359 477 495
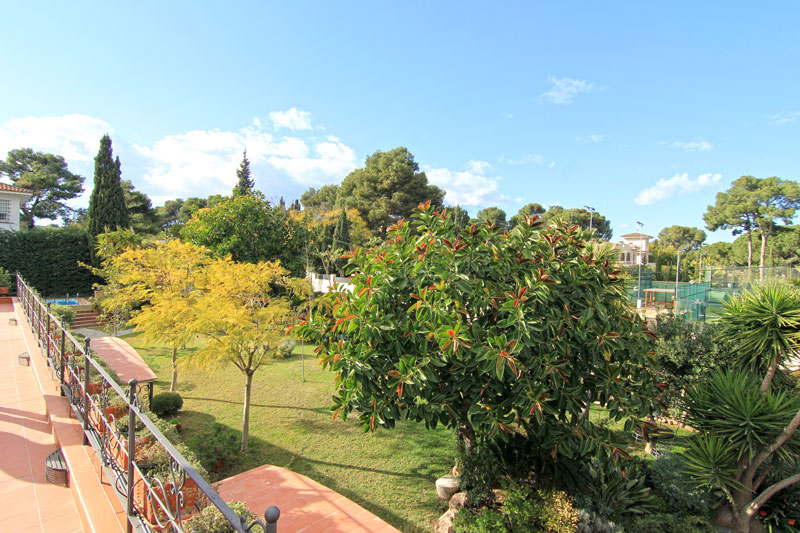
425 161 503 206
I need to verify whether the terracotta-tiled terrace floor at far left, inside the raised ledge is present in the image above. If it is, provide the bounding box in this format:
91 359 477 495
0 303 83 533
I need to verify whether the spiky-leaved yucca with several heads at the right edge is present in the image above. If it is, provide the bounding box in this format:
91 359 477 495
685 285 800 533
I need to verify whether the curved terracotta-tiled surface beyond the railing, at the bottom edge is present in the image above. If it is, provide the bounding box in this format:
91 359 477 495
217 465 398 533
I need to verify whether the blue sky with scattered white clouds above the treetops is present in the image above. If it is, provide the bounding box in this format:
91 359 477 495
0 1 800 242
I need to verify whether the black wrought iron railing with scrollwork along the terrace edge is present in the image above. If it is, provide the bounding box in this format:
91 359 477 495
17 274 280 533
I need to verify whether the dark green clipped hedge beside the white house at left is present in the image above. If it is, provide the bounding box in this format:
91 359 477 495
0 228 100 296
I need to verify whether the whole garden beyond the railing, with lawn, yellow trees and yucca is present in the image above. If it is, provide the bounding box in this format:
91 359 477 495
79 204 800 533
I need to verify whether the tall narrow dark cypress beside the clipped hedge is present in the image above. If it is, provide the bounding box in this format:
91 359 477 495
87 134 129 264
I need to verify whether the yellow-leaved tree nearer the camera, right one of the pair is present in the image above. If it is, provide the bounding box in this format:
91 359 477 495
190 258 296 452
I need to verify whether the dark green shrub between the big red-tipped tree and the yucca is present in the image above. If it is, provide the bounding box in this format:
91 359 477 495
653 313 736 408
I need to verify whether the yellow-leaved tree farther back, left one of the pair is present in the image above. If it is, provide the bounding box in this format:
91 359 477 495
101 239 212 391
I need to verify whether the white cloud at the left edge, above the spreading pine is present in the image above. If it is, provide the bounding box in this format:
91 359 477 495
0 114 114 161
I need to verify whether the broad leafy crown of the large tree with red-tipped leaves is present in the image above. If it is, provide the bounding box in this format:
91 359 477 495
295 204 658 464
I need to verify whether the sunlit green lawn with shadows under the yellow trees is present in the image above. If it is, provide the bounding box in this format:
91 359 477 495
125 335 455 532
